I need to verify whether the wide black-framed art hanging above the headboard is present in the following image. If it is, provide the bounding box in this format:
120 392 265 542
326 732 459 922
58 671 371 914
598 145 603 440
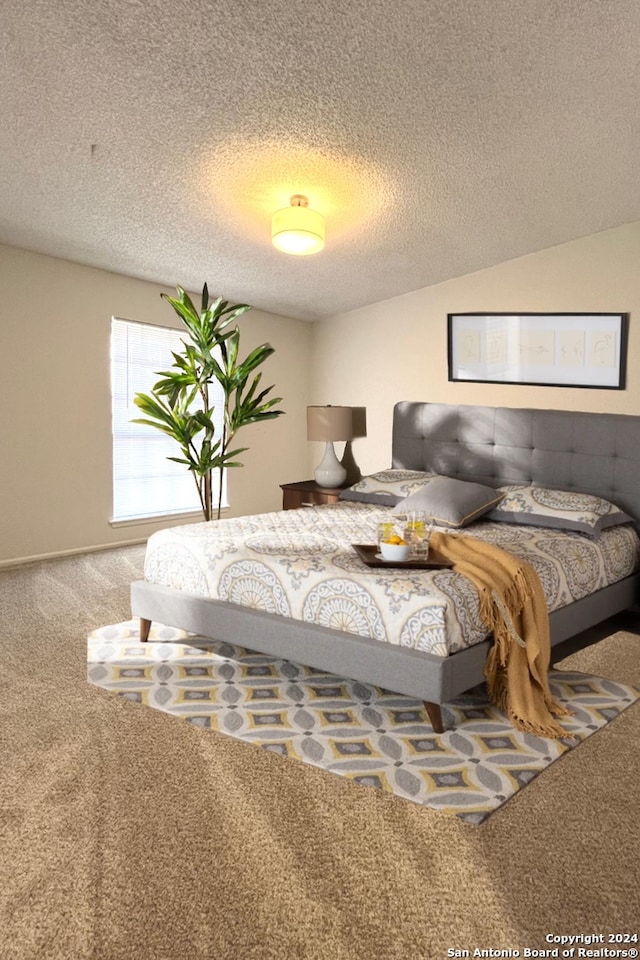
447 313 629 390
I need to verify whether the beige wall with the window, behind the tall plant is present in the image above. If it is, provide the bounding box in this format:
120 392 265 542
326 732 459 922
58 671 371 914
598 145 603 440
0 246 312 564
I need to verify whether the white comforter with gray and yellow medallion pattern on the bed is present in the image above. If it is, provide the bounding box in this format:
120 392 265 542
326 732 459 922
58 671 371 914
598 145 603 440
144 502 640 656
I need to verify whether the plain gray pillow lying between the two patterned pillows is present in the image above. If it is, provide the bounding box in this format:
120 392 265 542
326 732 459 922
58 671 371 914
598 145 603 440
393 477 504 527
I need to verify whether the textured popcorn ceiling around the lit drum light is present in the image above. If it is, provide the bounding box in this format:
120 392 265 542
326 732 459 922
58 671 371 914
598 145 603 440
0 0 640 320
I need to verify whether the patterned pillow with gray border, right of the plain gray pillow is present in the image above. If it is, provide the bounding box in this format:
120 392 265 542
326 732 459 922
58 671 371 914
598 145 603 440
487 484 633 537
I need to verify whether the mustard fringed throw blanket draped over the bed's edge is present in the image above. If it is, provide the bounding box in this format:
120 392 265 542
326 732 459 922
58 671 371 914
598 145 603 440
431 532 569 738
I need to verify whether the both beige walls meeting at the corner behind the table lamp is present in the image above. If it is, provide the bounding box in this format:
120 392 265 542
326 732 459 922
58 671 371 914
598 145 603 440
0 223 640 565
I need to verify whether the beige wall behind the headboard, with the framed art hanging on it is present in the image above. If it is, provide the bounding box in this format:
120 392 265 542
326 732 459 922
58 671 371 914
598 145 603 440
309 223 640 473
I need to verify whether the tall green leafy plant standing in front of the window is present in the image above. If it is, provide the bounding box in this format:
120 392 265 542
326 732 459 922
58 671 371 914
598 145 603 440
133 283 284 520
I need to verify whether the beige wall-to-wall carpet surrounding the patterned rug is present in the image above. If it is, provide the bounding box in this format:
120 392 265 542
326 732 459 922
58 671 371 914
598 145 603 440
0 548 640 960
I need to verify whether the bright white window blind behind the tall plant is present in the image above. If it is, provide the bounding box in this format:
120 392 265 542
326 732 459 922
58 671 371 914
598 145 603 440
111 317 227 521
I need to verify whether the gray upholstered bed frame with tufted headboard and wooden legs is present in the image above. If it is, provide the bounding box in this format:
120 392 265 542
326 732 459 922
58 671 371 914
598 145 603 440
131 402 640 732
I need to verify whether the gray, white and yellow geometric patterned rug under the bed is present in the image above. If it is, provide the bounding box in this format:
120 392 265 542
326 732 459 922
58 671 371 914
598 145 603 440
87 620 640 824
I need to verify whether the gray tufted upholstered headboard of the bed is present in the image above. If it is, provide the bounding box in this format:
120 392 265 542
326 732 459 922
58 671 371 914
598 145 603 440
392 402 640 522
